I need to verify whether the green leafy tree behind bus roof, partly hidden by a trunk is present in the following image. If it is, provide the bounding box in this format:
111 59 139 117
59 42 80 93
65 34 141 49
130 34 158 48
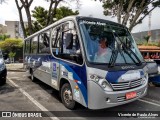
32 6 79 32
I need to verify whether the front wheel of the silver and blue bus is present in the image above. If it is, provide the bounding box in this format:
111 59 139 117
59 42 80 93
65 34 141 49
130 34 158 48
61 83 76 110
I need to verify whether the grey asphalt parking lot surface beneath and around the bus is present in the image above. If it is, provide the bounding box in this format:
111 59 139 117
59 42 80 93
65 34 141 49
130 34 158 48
0 72 160 120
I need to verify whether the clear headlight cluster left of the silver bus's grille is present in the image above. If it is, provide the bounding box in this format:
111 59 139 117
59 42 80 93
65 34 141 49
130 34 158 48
90 75 113 91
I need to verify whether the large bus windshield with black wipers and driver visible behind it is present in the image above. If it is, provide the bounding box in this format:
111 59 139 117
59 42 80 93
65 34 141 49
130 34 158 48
79 20 144 65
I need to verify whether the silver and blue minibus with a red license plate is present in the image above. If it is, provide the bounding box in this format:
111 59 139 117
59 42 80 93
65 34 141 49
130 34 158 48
24 16 148 109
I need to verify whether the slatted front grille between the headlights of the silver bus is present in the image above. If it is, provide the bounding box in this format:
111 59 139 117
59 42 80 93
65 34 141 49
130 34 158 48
110 79 142 91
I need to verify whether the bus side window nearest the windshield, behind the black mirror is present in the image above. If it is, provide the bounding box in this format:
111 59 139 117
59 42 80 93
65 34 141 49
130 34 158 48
62 22 83 64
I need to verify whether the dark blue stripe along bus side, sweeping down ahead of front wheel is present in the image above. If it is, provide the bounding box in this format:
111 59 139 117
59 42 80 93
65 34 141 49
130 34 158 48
26 55 88 105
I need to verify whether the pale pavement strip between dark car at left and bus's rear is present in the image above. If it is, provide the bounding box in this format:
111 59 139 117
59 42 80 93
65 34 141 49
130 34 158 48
6 63 25 72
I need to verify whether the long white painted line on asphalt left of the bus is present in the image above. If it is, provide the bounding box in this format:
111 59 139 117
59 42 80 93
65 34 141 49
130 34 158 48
7 78 59 120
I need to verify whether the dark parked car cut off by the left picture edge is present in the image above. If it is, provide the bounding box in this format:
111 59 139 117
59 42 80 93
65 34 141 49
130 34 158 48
0 50 7 85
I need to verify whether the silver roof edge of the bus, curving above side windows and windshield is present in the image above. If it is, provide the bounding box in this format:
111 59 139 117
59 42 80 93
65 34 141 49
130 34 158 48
25 16 127 40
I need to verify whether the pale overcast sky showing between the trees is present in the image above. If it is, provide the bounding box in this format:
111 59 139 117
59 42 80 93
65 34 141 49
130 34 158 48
0 0 160 33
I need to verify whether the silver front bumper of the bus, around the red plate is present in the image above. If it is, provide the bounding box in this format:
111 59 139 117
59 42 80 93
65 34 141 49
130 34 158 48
88 81 148 109
